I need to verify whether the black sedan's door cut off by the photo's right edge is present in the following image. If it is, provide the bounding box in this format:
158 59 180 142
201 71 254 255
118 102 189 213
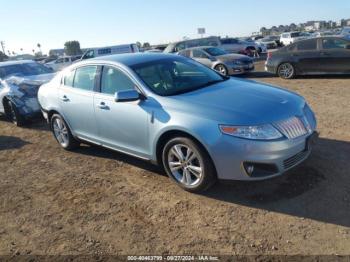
320 37 350 74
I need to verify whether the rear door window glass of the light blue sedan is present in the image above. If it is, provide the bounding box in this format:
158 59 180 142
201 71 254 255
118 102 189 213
73 66 97 91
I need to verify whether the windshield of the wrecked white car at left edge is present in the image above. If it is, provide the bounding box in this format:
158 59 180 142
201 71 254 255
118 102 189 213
0 62 52 79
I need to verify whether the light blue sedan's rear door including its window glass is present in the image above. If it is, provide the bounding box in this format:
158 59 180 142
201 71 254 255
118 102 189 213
59 65 98 140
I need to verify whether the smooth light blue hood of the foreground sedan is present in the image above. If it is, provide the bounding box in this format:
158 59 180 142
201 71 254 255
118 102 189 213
163 78 305 125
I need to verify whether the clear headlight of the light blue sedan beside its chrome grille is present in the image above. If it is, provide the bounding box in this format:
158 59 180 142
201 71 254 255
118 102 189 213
219 124 283 140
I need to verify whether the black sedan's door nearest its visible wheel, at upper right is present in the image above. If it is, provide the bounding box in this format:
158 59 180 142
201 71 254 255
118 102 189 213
292 38 320 73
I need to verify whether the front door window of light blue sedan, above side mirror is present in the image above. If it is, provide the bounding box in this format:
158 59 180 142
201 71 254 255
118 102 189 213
101 66 135 95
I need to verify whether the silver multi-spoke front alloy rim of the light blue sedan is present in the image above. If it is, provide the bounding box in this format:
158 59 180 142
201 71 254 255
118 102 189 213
168 144 203 186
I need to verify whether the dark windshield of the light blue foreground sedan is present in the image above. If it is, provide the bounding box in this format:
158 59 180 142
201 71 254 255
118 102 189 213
131 57 228 96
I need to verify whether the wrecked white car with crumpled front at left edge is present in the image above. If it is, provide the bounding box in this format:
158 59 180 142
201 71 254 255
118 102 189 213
0 61 54 126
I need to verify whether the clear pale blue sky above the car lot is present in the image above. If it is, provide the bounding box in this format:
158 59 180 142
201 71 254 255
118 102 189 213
0 0 350 54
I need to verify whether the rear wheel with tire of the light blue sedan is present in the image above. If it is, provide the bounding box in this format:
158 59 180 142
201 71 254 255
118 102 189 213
50 114 80 150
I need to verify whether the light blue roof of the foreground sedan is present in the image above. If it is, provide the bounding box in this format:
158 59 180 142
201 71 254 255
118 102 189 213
87 53 181 66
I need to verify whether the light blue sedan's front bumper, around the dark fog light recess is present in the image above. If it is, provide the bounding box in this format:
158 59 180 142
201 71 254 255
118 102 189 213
211 132 318 181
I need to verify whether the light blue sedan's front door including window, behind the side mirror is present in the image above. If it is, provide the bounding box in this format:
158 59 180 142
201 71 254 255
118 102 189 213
94 66 150 157
